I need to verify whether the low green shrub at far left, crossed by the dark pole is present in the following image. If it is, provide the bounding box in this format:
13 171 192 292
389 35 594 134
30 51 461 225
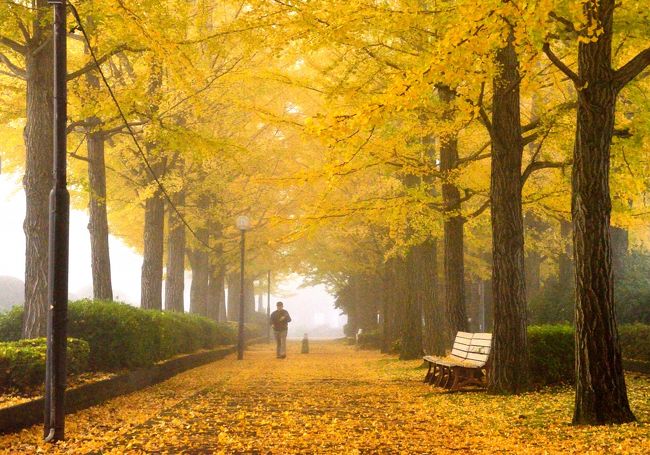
0 338 90 391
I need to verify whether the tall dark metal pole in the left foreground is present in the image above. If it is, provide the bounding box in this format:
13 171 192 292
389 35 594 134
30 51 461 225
44 0 70 442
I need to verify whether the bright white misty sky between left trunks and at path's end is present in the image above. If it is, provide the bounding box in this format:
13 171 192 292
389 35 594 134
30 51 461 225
0 174 346 338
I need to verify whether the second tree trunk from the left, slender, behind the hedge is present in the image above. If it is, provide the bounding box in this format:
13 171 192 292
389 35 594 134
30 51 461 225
87 132 113 300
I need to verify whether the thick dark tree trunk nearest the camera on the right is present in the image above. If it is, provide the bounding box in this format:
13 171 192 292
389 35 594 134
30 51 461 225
571 0 635 424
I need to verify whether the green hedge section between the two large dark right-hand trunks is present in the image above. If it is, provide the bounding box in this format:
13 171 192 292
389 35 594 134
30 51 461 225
528 325 575 385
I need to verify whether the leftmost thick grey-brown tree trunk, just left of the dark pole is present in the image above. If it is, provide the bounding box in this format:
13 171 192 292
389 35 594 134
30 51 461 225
22 0 54 338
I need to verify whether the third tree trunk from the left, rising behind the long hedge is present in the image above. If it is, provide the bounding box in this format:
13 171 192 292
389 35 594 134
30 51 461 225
140 192 165 310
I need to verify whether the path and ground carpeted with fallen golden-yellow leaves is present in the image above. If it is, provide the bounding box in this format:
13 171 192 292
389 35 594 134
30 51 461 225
0 342 650 454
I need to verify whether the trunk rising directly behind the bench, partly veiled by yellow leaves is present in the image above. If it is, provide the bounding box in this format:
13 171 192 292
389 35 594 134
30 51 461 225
438 86 468 343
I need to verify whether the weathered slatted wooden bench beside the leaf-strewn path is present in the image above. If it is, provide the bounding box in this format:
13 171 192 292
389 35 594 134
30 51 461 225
423 332 492 390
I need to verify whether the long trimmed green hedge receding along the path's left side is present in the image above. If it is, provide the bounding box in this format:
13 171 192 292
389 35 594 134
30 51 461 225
0 300 260 371
